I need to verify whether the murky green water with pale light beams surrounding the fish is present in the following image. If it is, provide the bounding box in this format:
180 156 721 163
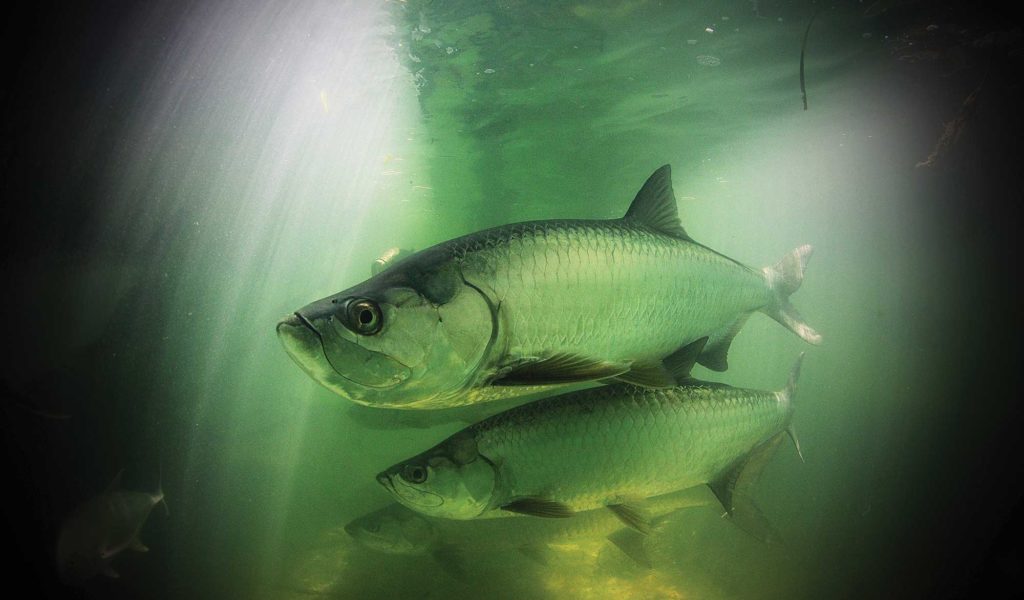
2 0 1024 599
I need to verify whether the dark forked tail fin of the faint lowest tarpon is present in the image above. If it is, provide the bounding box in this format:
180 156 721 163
708 433 786 544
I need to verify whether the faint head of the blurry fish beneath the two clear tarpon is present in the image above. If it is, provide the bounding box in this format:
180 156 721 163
345 504 437 554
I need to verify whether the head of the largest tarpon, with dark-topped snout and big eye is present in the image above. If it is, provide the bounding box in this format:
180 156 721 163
278 251 495 409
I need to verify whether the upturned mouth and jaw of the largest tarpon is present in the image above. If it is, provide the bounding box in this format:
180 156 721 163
276 310 412 397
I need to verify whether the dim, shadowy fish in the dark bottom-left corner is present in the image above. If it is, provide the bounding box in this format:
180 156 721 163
56 471 167 584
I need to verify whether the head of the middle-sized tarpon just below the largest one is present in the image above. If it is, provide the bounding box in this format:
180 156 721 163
377 431 498 519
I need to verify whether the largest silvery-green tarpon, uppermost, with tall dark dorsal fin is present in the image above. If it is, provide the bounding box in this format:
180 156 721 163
278 165 820 409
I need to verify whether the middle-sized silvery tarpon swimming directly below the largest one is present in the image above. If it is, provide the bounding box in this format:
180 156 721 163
377 340 803 541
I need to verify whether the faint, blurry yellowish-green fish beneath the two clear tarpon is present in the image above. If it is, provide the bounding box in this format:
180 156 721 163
345 483 710 576
